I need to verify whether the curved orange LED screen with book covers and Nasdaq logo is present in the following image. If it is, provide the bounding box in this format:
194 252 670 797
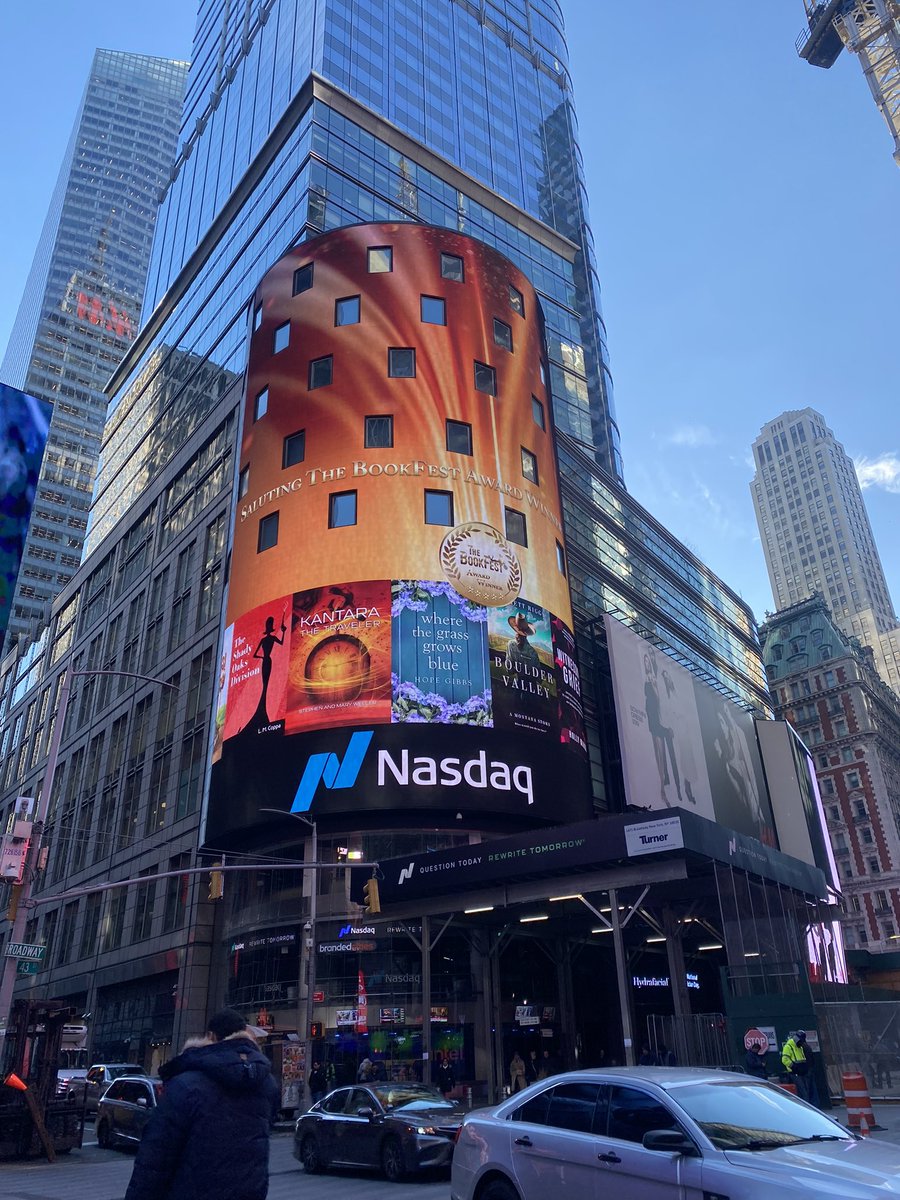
205 223 590 846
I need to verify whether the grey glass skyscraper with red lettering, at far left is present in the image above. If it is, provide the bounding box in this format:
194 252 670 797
0 50 187 635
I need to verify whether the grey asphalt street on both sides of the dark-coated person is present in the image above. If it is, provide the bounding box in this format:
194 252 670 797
0 1124 450 1200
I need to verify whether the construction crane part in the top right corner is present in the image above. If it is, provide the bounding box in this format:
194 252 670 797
797 0 900 166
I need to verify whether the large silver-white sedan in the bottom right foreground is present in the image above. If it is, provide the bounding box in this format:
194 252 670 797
450 1067 900 1200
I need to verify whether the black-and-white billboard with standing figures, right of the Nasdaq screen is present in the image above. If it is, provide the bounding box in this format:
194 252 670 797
605 614 778 846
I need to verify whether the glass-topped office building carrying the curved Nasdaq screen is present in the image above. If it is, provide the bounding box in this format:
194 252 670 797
0 0 823 1089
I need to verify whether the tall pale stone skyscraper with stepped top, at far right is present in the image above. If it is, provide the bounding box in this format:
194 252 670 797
750 408 900 690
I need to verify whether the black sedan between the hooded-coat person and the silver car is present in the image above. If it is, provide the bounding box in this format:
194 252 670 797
294 1084 466 1182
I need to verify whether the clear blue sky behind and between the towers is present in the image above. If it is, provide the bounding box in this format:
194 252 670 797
0 0 900 618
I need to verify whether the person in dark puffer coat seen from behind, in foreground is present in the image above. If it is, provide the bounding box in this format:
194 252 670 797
125 1008 281 1200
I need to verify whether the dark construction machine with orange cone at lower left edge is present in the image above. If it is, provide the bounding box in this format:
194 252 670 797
0 1000 84 1159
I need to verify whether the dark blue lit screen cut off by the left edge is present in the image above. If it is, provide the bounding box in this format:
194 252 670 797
0 383 52 650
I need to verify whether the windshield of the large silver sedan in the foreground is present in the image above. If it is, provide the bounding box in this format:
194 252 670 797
670 1080 851 1150
